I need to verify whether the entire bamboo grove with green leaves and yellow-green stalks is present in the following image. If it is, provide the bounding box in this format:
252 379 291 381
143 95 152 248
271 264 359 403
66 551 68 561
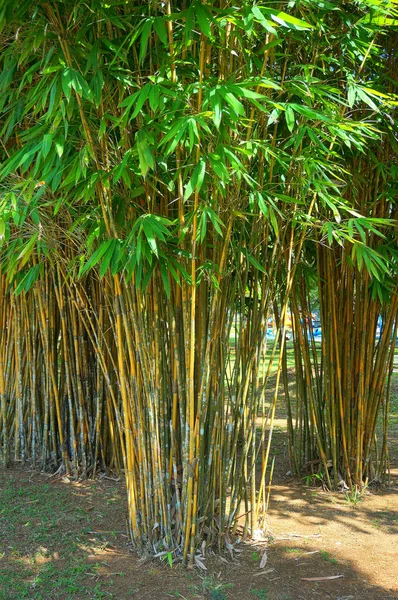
0 0 398 564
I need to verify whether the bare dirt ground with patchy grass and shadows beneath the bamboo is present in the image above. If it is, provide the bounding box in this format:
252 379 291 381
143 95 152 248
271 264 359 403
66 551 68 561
0 382 398 600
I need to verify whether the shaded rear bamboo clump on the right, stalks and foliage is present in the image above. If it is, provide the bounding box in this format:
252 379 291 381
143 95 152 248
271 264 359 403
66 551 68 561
288 25 398 488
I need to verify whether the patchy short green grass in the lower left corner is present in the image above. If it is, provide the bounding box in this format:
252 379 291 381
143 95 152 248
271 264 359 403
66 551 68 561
0 475 116 600
